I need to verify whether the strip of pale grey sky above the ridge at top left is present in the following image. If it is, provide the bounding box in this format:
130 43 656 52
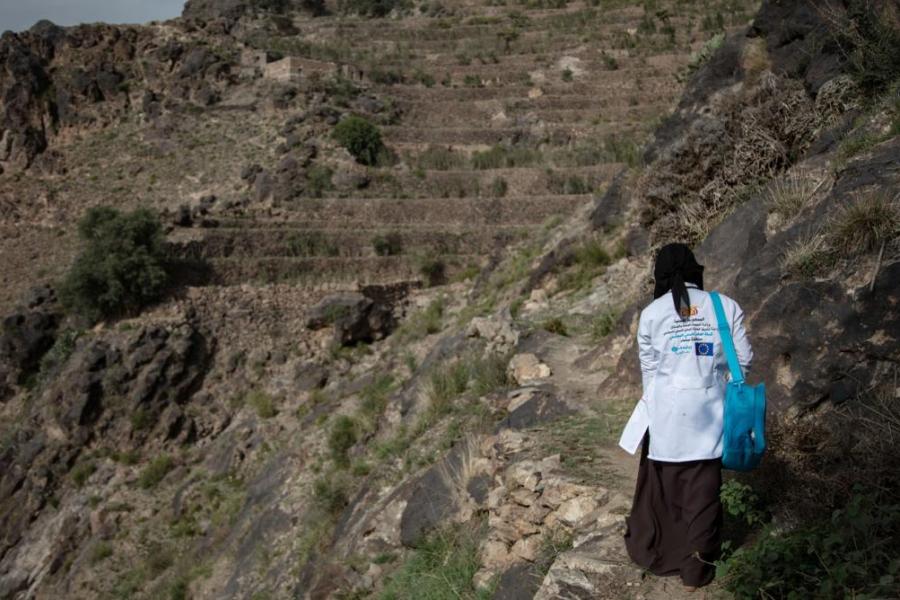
0 0 184 32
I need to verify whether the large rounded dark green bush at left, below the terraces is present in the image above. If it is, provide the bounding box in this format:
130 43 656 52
60 206 169 320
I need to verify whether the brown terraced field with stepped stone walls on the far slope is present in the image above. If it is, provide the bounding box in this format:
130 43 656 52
172 2 744 290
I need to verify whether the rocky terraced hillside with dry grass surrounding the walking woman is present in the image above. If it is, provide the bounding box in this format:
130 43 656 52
0 0 900 600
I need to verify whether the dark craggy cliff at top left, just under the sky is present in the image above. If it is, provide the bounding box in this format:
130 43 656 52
0 21 236 172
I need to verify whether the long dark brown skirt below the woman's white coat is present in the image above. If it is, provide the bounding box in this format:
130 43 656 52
625 434 722 587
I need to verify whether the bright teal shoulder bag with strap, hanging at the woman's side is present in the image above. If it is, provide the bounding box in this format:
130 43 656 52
709 292 766 471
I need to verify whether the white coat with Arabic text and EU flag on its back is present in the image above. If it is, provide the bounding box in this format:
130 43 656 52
619 283 753 462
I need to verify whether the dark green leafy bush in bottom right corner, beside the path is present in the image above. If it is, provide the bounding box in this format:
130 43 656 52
717 490 900 600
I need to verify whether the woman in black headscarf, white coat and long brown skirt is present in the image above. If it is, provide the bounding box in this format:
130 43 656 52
619 244 753 590
